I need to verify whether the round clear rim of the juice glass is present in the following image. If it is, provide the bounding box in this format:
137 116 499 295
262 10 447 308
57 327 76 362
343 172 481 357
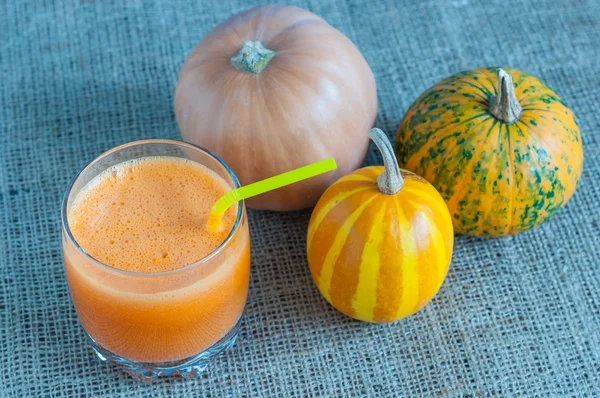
61 139 245 277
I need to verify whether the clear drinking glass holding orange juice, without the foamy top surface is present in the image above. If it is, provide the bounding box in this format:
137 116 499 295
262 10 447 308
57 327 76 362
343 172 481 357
62 140 250 382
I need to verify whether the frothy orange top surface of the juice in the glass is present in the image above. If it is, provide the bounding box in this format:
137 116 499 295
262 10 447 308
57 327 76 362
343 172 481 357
68 156 237 272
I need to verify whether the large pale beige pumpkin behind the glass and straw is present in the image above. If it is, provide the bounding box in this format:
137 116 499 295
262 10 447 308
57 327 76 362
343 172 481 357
175 6 377 210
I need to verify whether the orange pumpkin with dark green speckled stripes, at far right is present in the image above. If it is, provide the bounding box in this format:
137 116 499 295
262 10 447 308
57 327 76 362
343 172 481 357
396 68 583 236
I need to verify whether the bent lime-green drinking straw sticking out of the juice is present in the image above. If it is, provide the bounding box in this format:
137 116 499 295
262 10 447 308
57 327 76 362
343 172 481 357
207 158 337 232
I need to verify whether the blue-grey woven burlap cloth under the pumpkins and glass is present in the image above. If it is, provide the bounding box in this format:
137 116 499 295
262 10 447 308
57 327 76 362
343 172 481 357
0 0 600 397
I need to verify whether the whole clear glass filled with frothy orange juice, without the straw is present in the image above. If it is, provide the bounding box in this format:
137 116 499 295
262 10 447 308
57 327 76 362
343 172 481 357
62 140 250 381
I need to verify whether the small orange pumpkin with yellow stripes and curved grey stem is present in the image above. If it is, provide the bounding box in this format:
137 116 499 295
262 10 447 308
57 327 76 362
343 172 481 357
307 129 454 323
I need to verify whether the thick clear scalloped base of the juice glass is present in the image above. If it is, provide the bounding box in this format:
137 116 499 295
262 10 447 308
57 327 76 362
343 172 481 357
86 317 242 383
